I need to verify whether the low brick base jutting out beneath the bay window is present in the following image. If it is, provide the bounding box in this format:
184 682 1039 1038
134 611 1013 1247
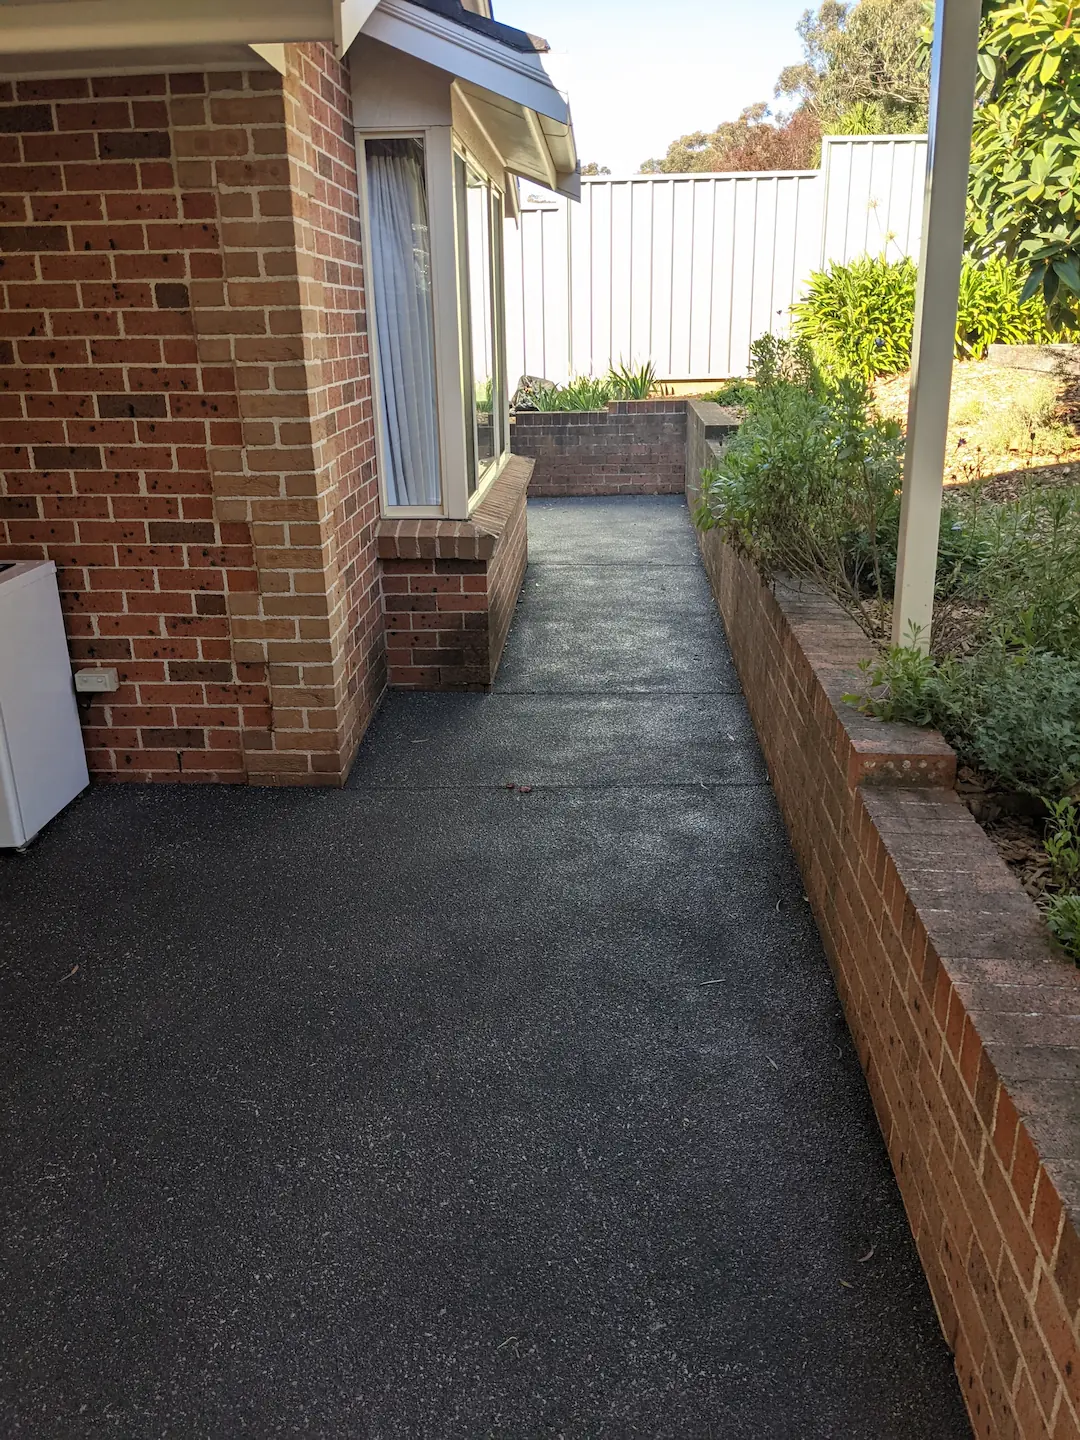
379 456 533 690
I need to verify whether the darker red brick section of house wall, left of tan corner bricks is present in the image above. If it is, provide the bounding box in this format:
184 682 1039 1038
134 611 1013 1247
0 76 269 779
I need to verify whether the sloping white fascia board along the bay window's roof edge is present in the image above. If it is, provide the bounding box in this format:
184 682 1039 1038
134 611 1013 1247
363 0 570 125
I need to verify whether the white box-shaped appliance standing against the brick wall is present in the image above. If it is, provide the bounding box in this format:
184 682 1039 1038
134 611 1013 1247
0 560 89 848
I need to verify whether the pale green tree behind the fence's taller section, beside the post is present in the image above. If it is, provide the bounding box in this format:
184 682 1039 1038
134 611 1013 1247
776 0 930 134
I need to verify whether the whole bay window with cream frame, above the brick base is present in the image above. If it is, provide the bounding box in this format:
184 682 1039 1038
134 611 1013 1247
363 127 510 520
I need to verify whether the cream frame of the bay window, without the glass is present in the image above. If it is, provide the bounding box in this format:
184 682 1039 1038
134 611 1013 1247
356 125 510 520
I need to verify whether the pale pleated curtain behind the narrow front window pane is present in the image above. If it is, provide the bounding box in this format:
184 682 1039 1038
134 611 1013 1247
367 140 441 505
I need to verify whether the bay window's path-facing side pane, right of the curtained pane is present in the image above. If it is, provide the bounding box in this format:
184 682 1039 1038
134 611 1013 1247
454 154 507 495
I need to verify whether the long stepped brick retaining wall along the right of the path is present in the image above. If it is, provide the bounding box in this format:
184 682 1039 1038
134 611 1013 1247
687 400 1080 1440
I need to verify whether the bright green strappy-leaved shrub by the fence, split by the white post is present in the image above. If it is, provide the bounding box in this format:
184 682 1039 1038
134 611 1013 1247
792 255 1051 380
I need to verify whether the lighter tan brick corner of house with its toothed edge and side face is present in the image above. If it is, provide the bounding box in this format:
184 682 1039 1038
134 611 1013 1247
217 45 386 783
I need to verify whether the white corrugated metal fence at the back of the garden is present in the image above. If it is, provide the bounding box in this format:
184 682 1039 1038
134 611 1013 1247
505 135 926 382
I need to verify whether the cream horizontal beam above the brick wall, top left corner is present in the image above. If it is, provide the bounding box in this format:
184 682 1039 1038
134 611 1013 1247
0 0 338 55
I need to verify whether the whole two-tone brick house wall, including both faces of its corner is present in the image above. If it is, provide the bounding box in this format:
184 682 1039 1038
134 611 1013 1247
0 45 384 783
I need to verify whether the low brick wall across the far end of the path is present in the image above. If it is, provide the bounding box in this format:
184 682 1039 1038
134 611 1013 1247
511 399 687 497
